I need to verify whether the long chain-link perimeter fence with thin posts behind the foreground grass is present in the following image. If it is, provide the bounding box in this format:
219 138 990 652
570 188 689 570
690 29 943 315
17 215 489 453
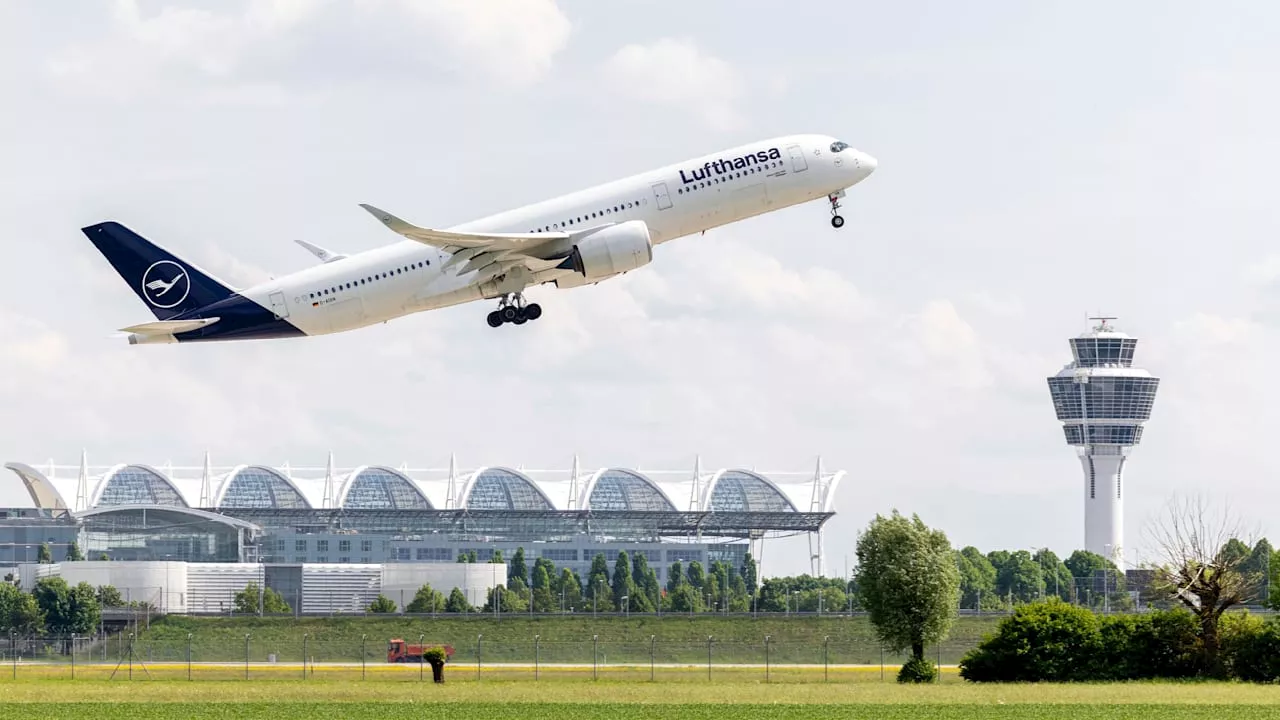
0 632 975 683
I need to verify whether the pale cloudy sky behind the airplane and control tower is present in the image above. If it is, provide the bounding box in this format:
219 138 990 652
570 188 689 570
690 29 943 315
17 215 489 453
0 0 1280 574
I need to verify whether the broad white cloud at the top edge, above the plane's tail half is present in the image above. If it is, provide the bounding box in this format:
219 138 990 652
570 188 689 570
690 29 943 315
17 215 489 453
47 0 571 98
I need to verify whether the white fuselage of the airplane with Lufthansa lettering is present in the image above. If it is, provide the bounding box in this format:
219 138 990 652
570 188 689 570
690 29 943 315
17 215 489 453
241 135 876 334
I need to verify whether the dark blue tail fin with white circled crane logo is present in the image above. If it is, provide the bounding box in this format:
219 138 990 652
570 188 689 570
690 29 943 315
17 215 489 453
81 223 236 320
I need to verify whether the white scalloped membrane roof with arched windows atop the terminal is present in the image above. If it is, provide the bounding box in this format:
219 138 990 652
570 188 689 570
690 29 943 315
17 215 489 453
5 462 844 512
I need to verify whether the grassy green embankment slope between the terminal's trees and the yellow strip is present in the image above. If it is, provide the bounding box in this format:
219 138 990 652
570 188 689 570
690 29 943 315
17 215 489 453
96 615 998 664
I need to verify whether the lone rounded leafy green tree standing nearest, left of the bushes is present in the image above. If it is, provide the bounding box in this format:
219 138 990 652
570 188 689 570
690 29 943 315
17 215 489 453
855 510 960 679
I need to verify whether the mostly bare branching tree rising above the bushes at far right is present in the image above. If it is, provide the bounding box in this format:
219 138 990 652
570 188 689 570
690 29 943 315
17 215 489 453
1146 496 1260 676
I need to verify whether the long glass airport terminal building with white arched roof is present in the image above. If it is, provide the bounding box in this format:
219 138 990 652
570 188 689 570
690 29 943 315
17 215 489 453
0 456 844 604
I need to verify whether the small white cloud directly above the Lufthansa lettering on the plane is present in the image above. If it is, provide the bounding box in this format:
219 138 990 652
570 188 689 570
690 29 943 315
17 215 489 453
602 37 747 131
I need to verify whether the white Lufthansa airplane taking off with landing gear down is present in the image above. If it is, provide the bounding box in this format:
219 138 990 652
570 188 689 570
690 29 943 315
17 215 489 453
81 135 877 345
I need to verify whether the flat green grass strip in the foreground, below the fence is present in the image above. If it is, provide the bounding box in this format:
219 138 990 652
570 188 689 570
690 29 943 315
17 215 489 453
0 680 1280 720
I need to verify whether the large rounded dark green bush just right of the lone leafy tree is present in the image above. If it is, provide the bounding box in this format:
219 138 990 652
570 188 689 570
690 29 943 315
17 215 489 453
960 597 1103 683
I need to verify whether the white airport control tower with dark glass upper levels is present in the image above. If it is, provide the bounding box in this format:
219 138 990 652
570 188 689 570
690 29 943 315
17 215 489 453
1048 318 1160 568
